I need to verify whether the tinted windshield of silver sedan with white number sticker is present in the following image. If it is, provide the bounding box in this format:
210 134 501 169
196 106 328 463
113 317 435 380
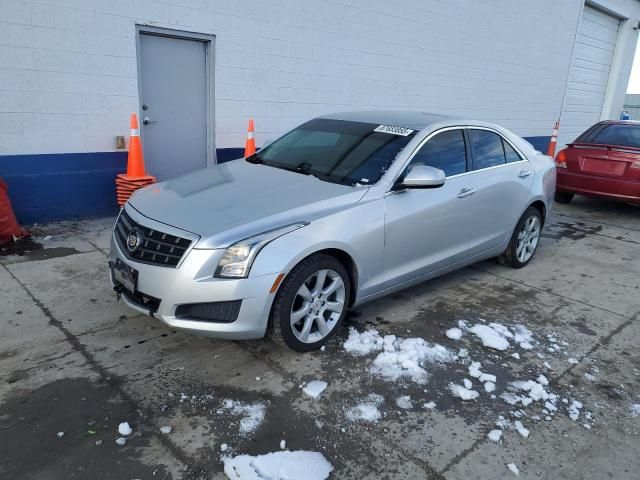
247 119 416 185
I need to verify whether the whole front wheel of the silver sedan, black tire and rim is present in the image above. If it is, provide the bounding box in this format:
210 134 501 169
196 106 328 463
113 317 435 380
269 254 351 352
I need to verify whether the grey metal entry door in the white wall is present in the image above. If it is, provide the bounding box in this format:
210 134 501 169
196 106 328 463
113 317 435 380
138 32 209 181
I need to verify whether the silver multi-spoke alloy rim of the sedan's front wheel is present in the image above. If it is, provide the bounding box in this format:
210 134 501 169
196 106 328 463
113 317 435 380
289 269 346 343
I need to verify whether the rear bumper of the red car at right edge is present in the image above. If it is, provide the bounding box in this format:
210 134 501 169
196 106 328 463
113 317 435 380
556 168 640 203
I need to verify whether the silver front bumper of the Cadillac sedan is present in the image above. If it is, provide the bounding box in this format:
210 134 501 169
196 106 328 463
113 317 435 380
109 235 278 340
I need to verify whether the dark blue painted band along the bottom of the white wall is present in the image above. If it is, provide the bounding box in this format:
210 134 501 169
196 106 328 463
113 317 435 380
0 137 550 225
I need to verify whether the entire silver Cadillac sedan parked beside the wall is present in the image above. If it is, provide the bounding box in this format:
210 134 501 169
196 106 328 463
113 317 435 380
109 112 556 351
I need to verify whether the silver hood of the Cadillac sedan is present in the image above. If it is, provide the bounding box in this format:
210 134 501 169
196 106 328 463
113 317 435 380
129 160 368 249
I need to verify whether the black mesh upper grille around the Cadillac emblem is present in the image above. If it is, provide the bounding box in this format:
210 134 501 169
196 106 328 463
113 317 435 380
115 210 191 267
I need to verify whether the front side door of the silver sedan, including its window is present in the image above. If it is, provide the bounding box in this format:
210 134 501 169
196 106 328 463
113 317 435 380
383 128 475 288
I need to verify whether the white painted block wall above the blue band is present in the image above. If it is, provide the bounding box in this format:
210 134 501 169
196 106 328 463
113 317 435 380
0 0 640 154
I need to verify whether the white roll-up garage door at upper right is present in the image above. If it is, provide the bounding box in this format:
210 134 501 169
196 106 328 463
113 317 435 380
558 6 620 146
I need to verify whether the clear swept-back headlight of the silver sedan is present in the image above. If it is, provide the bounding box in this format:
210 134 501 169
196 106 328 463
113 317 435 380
215 222 308 278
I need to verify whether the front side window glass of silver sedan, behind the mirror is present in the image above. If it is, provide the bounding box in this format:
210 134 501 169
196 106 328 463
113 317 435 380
411 130 467 177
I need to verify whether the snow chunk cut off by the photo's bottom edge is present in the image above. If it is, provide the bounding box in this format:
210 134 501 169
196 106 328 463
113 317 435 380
222 450 333 480
